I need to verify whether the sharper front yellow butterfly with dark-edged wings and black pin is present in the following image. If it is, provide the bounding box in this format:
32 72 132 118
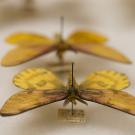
0 64 135 116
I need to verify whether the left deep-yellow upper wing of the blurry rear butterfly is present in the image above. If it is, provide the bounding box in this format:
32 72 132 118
6 33 54 46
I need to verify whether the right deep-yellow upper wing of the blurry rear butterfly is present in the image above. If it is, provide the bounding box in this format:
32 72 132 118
67 30 108 44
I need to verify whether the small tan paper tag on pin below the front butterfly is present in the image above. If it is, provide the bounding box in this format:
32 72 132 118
58 109 86 123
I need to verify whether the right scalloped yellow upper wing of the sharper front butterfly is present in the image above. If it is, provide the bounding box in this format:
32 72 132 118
80 70 130 90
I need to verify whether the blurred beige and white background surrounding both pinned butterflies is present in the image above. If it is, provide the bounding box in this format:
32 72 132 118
0 0 135 135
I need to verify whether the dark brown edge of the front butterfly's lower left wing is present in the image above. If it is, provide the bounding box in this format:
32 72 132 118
0 90 67 117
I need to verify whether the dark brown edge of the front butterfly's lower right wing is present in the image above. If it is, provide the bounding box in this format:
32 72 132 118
79 90 135 116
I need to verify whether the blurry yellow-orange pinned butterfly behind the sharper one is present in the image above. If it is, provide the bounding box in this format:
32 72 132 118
1 18 131 66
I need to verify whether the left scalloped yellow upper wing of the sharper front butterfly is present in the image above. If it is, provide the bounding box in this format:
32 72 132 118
13 68 65 90
